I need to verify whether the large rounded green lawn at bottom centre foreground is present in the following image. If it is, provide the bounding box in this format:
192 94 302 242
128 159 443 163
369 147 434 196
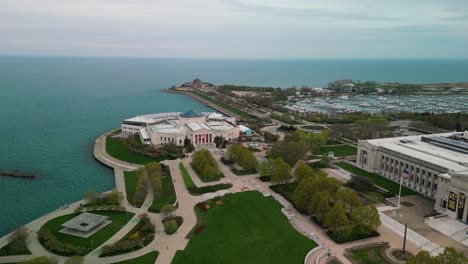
172 192 317 264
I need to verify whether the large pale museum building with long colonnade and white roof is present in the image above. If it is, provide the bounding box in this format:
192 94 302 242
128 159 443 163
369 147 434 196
356 131 468 222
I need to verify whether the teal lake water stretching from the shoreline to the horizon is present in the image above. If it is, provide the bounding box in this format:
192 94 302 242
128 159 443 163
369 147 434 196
0 57 468 236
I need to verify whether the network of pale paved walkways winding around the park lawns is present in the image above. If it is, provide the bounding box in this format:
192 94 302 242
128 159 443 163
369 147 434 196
0 132 430 264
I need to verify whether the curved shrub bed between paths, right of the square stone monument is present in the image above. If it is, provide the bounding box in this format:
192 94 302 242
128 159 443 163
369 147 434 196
101 214 155 256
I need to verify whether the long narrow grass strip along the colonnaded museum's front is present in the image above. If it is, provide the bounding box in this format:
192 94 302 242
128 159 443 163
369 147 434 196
335 162 417 196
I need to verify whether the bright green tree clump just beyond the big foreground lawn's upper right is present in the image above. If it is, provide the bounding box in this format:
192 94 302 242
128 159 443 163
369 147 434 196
259 158 291 184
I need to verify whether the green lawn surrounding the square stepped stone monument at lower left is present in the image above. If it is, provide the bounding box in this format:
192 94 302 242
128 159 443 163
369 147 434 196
41 211 134 252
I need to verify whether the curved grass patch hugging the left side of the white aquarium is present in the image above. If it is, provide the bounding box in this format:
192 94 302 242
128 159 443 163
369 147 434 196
106 136 158 164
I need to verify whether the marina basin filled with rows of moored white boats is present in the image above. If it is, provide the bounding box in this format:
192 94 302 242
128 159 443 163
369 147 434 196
284 94 468 114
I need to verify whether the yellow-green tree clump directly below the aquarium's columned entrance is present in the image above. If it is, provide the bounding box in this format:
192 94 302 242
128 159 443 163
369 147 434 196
192 149 221 180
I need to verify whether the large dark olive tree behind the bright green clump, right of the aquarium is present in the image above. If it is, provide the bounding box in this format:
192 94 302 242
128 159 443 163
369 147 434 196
270 141 307 167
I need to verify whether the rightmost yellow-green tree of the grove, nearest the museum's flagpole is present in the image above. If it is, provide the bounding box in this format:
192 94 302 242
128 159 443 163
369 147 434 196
351 205 381 234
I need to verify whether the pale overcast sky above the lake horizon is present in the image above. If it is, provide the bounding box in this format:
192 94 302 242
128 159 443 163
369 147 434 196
0 0 468 59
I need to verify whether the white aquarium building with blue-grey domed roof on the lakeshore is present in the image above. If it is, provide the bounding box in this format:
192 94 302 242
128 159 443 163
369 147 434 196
122 110 239 146
